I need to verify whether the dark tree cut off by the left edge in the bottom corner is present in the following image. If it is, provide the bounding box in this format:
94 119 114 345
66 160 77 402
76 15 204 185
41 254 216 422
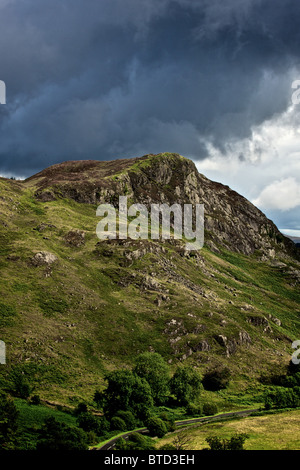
0 394 19 450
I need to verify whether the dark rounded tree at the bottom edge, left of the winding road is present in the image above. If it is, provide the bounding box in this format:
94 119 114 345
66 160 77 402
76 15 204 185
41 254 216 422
37 417 88 451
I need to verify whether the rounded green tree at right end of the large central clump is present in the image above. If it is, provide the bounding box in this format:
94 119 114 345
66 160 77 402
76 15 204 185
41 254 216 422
170 366 201 405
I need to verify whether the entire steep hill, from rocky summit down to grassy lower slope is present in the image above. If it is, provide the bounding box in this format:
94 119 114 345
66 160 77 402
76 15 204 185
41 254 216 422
0 154 300 402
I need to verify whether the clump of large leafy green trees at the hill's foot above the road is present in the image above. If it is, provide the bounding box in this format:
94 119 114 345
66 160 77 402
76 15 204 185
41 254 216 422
94 353 202 422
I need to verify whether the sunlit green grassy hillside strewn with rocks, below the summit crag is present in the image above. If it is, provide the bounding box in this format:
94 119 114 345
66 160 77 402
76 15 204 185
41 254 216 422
0 164 300 404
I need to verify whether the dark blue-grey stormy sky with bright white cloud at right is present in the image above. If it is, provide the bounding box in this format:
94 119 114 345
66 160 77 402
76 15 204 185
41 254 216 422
0 0 300 234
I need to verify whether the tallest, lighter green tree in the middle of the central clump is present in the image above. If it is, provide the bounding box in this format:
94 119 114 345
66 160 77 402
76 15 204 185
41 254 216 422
134 352 170 404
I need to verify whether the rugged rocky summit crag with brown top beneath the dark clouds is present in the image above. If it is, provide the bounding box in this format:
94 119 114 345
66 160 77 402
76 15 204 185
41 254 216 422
26 154 299 260
